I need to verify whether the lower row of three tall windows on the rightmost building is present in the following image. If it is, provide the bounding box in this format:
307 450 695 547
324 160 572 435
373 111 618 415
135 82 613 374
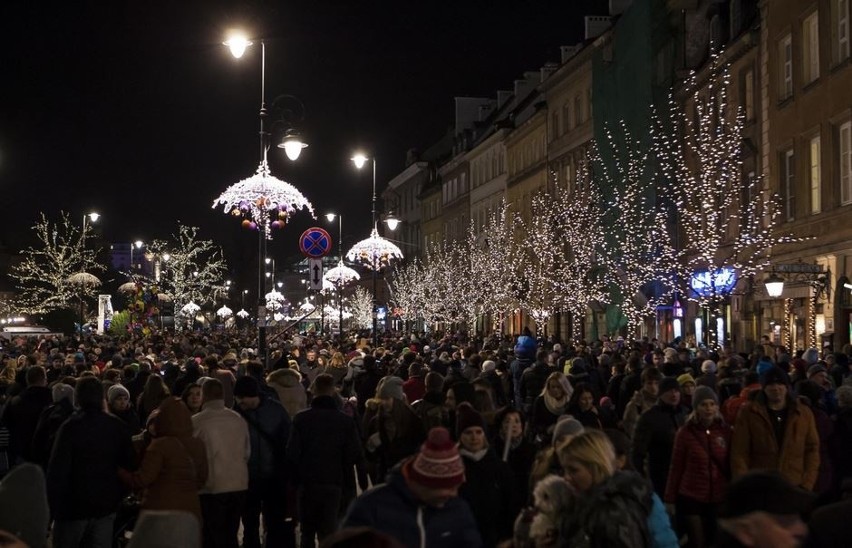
779 120 852 221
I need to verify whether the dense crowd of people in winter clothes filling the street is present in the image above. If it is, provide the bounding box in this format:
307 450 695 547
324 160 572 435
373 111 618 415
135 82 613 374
0 331 852 548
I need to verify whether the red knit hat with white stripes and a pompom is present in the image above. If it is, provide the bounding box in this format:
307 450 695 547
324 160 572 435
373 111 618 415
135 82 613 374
406 426 464 489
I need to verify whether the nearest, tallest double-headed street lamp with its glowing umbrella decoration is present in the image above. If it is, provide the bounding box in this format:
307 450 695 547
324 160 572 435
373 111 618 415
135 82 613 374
213 33 313 364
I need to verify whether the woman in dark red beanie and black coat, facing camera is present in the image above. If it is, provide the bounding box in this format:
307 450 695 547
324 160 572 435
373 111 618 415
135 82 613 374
456 403 521 546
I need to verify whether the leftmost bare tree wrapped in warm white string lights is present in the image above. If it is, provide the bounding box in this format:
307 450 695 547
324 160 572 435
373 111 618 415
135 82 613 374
10 212 104 314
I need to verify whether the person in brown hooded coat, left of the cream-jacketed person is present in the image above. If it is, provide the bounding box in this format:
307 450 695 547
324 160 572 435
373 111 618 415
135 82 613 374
119 398 208 530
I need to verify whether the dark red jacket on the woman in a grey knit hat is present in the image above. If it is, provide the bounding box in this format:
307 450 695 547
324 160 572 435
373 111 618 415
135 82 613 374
664 419 731 503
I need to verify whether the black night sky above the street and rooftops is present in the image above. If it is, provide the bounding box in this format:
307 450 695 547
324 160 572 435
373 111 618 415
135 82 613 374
0 0 606 279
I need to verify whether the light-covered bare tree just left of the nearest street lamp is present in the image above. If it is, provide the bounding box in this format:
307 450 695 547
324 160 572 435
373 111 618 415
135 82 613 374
148 225 228 310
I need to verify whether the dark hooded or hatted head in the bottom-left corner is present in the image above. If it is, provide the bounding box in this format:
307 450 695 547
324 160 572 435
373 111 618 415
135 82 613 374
0 463 50 548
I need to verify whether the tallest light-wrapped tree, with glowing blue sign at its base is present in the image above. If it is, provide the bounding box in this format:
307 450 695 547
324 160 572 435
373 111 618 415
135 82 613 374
653 56 801 337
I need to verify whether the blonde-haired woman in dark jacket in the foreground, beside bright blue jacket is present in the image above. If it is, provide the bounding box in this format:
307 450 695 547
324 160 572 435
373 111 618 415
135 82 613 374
559 429 652 548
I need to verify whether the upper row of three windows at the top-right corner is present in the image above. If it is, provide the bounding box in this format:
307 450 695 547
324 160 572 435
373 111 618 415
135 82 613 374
778 0 850 101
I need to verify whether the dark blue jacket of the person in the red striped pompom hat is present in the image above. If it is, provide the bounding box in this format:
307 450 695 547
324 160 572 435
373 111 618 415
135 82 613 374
343 461 482 548
